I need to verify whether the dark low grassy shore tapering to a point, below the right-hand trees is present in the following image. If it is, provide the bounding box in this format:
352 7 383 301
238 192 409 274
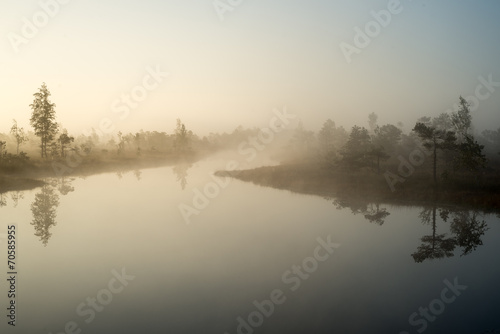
215 164 500 212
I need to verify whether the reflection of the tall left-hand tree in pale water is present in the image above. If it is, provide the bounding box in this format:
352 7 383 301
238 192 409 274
31 185 59 246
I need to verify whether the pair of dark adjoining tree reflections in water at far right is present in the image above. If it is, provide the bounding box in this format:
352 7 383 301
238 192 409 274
412 205 488 262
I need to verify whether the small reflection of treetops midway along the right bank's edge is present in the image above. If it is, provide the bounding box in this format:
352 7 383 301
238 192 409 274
326 197 390 225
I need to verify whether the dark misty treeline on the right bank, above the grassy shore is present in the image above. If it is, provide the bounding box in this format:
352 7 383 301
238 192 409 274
281 97 500 187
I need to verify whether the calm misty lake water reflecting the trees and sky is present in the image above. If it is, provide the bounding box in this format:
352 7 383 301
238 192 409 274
0 157 500 334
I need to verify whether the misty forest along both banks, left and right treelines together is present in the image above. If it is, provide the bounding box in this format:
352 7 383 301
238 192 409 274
0 84 500 189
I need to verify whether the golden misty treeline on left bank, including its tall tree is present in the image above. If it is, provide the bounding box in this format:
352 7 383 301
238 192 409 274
0 83 280 173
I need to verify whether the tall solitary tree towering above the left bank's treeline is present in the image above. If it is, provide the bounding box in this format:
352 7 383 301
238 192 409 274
30 83 58 158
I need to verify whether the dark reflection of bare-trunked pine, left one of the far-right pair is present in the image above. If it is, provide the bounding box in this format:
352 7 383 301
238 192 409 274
411 205 456 263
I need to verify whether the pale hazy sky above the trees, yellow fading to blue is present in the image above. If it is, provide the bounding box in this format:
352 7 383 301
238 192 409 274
0 0 500 134
